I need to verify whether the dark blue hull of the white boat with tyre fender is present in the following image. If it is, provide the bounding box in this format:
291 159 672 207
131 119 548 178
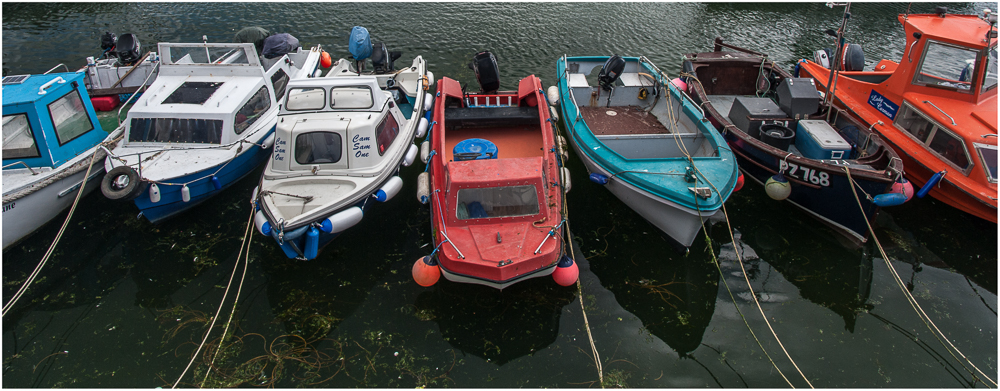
134 126 274 224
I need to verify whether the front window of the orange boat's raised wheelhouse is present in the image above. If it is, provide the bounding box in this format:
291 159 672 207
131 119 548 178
913 40 978 91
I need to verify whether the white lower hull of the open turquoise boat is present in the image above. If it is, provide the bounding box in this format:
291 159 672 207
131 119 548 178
570 137 723 247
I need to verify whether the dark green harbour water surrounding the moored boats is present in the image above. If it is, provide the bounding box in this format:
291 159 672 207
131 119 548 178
0 2 997 388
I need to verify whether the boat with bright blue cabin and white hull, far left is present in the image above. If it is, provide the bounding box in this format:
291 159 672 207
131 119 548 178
3 73 122 249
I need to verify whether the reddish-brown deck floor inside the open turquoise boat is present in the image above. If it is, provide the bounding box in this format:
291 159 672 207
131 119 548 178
580 106 670 136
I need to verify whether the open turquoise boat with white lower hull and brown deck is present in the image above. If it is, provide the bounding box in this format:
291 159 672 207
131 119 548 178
549 56 739 248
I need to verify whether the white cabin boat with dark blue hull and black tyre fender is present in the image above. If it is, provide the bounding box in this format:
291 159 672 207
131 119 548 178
101 40 321 223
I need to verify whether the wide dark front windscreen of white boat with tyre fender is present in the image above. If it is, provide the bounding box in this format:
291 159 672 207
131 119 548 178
128 118 222 144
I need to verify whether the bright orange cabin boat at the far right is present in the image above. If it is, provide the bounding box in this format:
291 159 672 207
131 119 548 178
795 7 997 223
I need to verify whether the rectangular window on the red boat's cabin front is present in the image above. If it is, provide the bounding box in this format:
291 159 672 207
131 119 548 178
455 185 538 220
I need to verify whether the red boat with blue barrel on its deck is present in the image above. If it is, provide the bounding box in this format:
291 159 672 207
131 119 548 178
413 52 579 289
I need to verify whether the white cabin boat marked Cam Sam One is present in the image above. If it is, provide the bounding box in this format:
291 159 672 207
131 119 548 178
253 43 434 260
